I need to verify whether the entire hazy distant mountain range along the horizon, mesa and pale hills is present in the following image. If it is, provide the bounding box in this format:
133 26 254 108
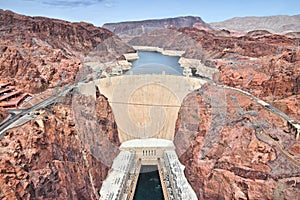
103 14 300 36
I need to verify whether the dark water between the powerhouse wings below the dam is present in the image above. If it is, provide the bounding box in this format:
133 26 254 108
134 165 164 200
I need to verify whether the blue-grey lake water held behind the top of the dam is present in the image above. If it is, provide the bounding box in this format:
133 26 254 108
126 51 183 75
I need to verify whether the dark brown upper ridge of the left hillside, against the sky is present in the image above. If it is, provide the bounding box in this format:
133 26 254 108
0 10 113 53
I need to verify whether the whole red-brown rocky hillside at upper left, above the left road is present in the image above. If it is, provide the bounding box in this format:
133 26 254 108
0 10 133 93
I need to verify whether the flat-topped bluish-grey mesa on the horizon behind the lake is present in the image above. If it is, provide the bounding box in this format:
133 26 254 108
103 16 210 36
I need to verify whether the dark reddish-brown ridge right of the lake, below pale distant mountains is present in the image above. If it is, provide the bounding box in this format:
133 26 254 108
177 28 296 59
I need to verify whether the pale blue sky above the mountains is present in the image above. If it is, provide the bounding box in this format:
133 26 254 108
0 0 300 26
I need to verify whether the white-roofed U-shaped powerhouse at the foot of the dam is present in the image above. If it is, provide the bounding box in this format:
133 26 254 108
100 138 197 200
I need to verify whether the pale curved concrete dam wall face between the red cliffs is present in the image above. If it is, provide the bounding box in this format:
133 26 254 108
95 74 205 142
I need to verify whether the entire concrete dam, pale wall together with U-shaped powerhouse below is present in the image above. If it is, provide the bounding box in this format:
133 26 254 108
78 74 206 199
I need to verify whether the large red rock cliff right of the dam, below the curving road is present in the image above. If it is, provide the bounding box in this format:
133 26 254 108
174 85 300 199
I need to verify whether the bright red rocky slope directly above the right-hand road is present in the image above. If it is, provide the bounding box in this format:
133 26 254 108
219 50 300 101
